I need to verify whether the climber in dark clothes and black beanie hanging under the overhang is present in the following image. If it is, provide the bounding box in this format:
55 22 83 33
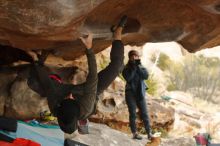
28 16 127 133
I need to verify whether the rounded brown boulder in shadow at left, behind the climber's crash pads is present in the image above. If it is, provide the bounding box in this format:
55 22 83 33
5 78 48 119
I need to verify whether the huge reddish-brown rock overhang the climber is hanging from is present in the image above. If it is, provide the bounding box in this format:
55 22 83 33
0 0 220 59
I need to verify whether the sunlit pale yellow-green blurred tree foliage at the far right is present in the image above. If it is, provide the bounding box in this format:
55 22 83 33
168 55 220 101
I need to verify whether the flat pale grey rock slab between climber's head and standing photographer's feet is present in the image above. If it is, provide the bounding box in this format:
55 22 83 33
70 123 150 146
